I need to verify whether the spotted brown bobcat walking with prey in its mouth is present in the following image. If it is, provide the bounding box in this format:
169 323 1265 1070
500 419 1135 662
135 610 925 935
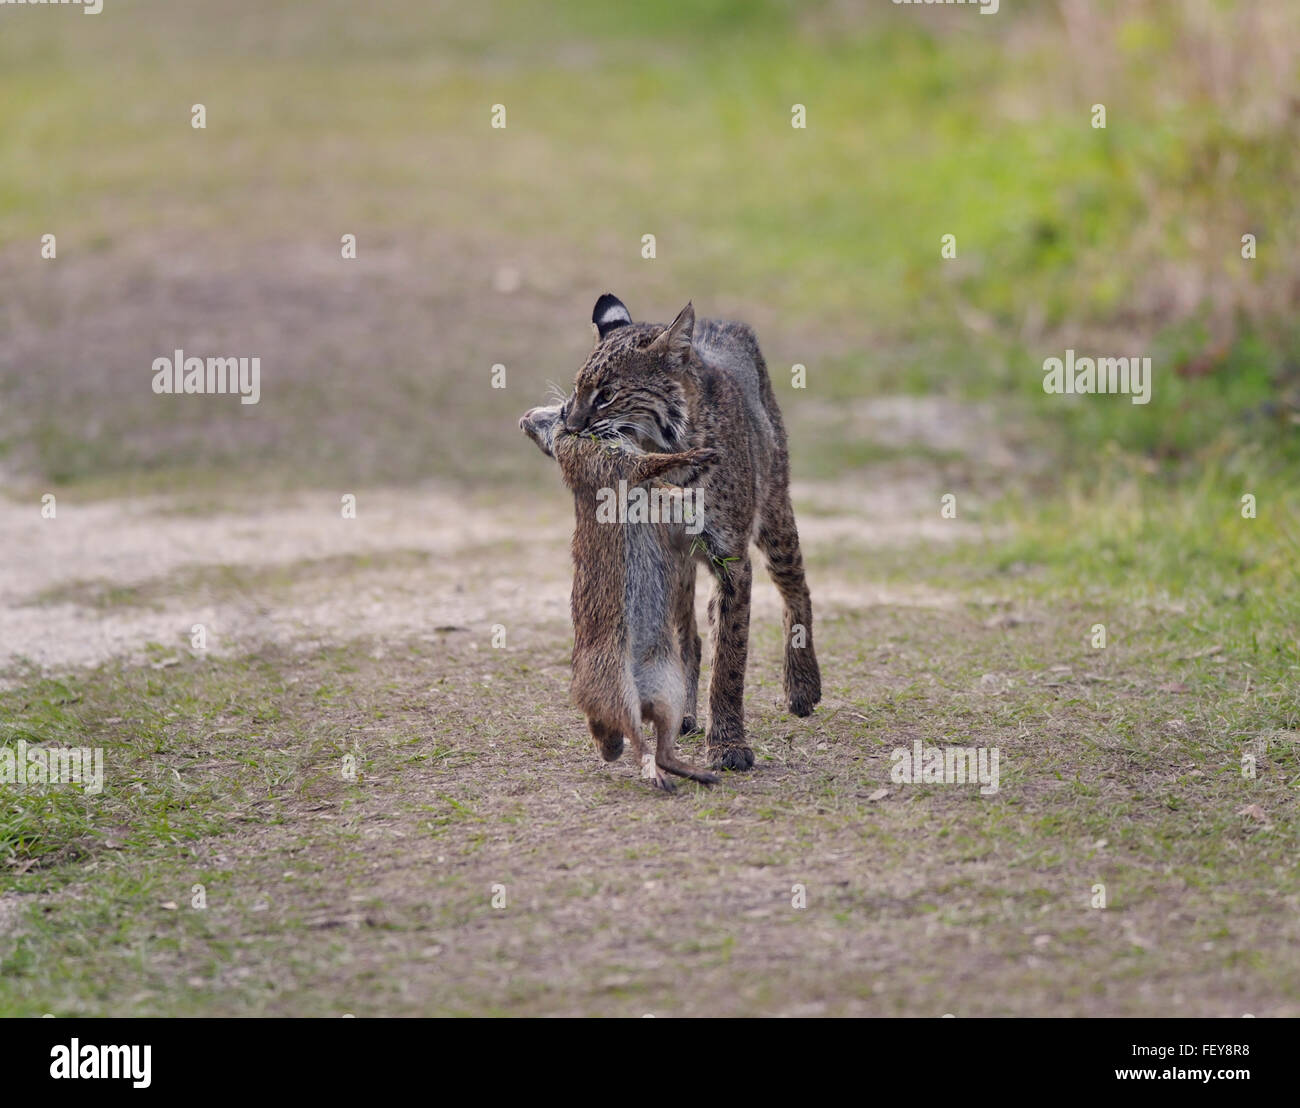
520 293 822 770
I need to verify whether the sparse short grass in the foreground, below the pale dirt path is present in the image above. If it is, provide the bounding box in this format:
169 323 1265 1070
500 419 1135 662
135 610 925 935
0 509 1300 1014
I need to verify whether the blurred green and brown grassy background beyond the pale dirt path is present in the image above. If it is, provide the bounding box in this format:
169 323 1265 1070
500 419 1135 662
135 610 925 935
0 0 1300 506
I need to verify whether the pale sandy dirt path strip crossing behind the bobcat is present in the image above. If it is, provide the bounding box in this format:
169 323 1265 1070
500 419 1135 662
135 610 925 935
0 447 971 672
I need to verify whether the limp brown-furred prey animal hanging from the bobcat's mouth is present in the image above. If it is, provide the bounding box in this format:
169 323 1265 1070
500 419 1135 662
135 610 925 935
519 407 718 792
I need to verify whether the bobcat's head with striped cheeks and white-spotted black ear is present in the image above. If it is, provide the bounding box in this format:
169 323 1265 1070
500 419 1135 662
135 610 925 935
560 293 696 451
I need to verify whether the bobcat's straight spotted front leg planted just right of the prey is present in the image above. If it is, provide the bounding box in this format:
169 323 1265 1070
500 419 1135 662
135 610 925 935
706 553 754 770
